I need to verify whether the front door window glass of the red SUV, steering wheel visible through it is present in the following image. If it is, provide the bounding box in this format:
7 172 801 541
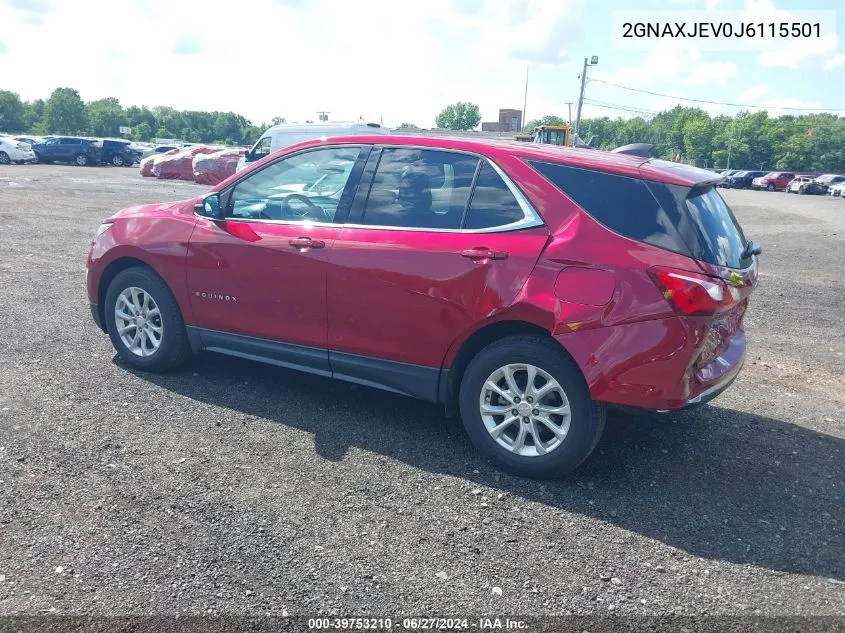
227 146 361 222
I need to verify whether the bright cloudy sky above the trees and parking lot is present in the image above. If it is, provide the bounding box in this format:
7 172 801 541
0 0 845 127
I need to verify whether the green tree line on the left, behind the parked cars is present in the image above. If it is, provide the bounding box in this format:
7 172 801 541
0 88 268 145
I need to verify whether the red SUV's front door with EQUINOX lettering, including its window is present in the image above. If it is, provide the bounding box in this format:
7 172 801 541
187 146 370 364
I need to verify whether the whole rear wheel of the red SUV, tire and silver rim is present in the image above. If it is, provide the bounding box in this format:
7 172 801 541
460 336 605 478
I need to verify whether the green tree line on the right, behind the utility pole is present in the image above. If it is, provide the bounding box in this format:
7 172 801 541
525 105 845 173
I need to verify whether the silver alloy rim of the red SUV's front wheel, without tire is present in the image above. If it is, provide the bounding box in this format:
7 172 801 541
114 286 164 356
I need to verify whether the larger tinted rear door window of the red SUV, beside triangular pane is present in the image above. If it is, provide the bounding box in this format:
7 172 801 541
361 148 478 229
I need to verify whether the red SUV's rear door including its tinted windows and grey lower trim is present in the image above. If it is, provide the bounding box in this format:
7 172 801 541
328 147 549 399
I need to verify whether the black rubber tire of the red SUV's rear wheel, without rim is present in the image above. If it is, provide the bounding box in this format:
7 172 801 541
459 335 606 478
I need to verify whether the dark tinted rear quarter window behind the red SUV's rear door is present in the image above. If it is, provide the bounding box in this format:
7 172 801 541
531 162 690 255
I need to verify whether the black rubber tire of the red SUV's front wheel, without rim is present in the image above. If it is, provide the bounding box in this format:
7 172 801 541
104 267 191 372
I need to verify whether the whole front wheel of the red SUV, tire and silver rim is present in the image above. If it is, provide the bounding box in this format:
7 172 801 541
104 267 191 372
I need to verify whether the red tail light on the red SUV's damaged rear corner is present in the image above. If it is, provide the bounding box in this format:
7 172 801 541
651 269 739 315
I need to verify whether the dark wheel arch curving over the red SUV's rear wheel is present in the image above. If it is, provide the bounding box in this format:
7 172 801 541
438 319 583 415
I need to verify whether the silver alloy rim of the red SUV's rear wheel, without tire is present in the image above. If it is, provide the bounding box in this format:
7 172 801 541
479 363 572 457
